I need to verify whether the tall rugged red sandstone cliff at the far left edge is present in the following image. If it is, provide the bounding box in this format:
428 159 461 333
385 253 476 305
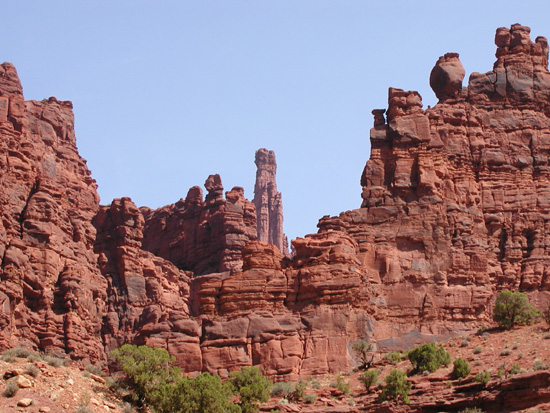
0 63 106 360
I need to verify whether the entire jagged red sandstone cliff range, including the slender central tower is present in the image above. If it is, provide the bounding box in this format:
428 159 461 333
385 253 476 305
0 24 550 380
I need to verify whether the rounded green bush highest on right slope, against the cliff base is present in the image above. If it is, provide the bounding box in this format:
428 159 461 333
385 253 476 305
493 290 538 329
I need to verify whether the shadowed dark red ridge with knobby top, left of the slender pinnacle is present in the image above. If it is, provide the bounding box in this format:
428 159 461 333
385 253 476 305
142 175 256 274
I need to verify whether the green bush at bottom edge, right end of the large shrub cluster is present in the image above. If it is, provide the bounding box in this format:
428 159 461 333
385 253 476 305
229 366 272 413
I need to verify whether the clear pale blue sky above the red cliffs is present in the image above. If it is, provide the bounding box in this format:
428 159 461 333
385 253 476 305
4 0 550 238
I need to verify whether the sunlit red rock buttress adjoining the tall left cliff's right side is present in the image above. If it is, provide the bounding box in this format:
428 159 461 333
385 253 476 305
94 198 202 371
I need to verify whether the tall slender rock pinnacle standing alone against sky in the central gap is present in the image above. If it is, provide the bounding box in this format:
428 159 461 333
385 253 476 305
252 148 288 255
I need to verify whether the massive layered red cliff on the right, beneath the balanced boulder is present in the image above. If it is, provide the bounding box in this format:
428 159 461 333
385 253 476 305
348 25 550 333
